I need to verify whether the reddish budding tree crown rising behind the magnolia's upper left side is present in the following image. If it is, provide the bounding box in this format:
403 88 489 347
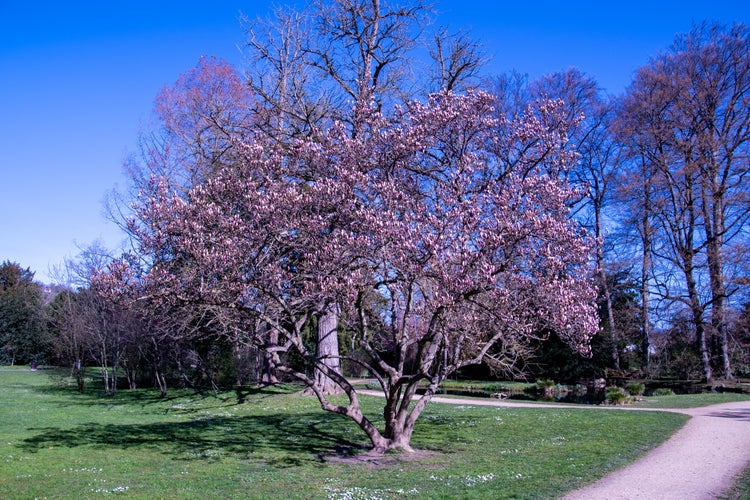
109 57 255 203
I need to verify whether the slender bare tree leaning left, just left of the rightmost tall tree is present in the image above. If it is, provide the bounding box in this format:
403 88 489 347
621 54 713 380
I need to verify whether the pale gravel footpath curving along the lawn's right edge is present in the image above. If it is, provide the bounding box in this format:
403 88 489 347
358 391 750 500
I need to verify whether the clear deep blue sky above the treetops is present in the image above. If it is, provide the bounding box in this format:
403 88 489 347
0 0 750 282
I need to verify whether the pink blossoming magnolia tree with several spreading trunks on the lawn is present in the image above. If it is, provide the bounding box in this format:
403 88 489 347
110 92 598 452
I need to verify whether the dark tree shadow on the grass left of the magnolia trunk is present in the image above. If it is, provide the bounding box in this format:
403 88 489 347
18 412 362 467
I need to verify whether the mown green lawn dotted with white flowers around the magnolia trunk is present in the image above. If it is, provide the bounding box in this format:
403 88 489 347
0 371 686 499
